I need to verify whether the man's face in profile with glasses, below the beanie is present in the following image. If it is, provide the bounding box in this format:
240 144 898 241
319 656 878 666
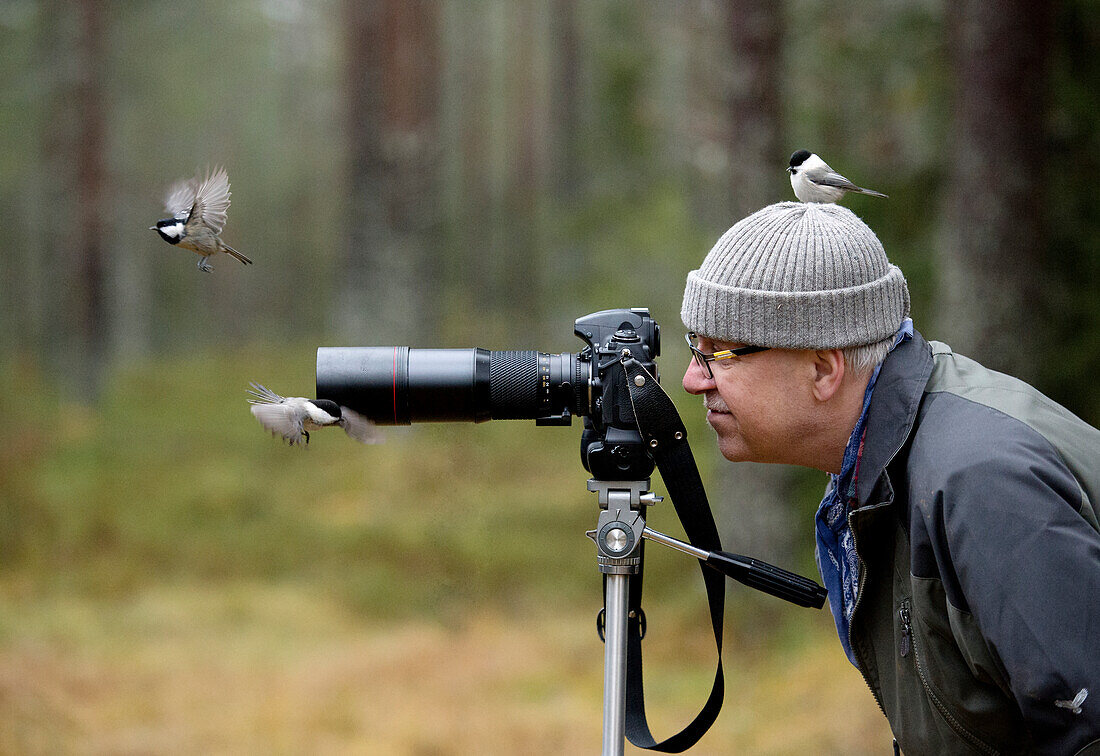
683 337 815 464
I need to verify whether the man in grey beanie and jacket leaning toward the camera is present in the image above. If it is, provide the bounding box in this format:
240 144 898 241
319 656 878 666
681 202 1100 756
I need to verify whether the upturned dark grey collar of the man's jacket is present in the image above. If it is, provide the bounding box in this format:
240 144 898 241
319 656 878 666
856 331 933 506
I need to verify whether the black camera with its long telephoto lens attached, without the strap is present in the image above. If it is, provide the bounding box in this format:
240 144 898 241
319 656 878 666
317 308 661 480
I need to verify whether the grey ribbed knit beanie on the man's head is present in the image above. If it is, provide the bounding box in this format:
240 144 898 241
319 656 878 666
680 202 909 349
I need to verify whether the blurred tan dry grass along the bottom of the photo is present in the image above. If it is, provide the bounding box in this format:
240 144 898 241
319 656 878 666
0 584 890 755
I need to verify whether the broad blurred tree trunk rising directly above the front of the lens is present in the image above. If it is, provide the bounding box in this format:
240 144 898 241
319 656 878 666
339 0 440 343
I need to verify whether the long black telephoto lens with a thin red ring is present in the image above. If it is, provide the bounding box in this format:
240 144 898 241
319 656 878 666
317 347 591 425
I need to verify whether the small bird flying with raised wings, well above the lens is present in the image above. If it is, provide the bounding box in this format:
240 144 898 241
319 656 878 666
149 168 252 273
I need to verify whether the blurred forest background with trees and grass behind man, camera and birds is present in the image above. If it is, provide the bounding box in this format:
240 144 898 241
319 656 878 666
0 0 1100 754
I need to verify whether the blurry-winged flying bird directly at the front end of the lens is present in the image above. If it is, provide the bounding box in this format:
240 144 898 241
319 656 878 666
249 383 382 446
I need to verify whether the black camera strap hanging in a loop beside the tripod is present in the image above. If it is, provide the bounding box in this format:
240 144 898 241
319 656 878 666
623 357 726 754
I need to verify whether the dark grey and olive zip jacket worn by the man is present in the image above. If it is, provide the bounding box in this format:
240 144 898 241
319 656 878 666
849 333 1100 756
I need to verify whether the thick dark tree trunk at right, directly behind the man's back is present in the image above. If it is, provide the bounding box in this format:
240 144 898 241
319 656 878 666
937 0 1053 379
